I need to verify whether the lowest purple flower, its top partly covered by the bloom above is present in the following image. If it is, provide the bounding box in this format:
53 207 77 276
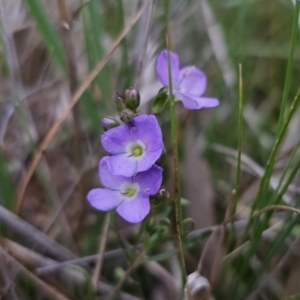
87 156 162 223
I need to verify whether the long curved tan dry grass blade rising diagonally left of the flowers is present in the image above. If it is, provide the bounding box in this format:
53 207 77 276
16 0 151 214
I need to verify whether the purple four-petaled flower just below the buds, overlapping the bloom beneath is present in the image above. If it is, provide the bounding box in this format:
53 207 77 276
101 115 163 177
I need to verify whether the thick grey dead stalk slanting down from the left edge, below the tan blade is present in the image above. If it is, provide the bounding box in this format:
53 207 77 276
0 205 75 260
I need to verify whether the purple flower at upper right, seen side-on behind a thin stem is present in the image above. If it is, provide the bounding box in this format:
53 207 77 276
156 50 219 109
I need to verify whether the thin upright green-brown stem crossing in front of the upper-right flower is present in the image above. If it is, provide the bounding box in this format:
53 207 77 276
167 37 186 287
